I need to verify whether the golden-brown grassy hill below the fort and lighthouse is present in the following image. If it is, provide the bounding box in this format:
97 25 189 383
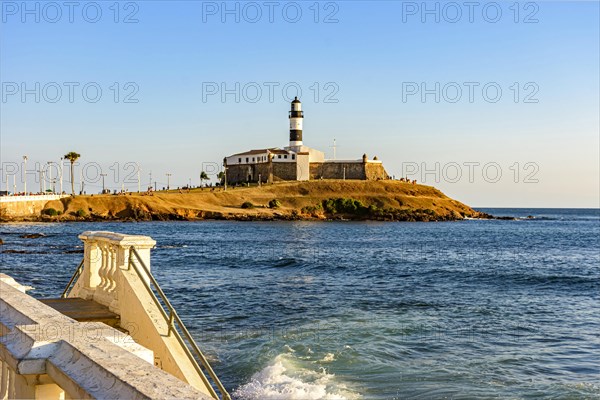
30 180 486 221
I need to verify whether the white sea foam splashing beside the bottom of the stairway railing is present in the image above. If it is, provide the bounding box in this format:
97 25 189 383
233 354 359 400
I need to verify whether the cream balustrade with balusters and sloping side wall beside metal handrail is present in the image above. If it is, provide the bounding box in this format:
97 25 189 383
68 232 223 396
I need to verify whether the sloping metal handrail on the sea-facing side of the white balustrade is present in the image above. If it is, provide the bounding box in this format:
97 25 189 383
128 247 231 400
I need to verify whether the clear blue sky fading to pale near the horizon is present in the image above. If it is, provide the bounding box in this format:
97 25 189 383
0 1 600 207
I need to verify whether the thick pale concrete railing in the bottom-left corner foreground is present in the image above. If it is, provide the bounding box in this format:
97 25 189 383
0 274 209 400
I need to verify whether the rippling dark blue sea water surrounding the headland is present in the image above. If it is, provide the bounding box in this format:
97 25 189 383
0 209 600 399
